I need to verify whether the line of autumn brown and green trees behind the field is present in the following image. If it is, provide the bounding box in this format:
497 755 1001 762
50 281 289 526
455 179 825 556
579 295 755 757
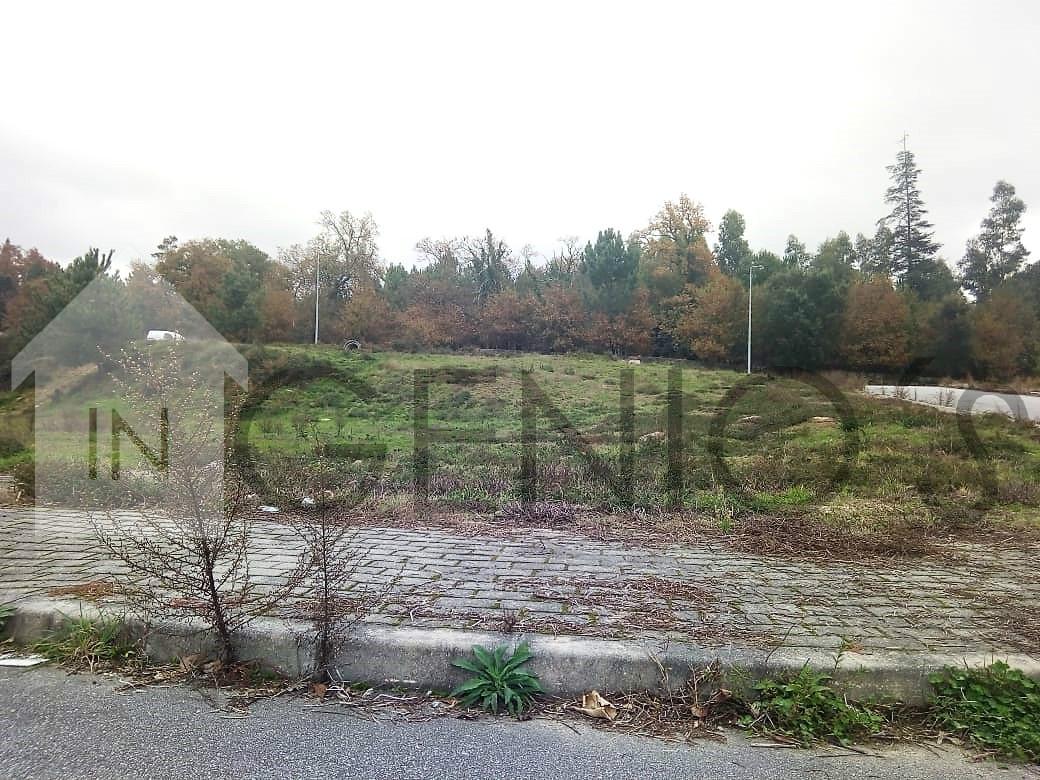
0 149 1040 379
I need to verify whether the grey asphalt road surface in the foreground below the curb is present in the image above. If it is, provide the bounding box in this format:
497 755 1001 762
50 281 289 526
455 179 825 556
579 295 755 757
0 668 1037 780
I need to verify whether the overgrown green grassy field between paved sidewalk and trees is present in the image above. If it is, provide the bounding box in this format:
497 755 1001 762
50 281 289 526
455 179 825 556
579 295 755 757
0 346 1040 544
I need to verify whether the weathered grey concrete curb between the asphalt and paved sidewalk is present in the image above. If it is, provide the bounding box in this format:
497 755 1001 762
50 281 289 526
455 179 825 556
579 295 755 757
2 598 1040 704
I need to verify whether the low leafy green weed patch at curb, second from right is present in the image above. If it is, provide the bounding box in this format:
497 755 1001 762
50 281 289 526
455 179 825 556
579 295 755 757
740 667 884 747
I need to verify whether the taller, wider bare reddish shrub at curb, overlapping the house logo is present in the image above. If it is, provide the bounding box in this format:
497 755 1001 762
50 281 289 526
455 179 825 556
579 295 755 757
90 349 298 662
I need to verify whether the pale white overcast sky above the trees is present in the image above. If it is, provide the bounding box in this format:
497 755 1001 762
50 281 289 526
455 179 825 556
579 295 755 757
0 0 1040 276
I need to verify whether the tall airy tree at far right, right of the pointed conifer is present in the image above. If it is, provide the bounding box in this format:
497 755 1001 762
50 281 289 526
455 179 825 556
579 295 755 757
958 181 1030 302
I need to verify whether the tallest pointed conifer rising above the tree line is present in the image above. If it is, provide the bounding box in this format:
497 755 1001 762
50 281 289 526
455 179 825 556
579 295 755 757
879 145 939 294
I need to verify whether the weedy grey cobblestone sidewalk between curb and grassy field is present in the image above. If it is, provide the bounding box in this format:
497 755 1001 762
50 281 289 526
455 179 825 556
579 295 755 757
0 509 1040 657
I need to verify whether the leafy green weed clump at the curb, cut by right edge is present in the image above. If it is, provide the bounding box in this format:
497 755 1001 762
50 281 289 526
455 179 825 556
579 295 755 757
929 661 1040 761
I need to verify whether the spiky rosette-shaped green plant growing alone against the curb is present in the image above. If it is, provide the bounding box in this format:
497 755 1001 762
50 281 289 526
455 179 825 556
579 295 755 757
451 643 543 716
